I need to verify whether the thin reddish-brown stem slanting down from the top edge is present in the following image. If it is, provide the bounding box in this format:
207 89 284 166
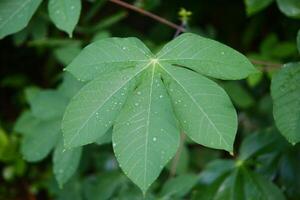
109 0 186 32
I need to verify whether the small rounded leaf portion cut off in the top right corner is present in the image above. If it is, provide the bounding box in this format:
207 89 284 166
276 0 300 19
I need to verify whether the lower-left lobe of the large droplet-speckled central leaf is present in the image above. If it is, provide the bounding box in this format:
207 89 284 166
62 68 141 147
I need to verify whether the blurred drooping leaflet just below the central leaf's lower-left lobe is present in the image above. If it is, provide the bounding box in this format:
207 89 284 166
53 139 82 187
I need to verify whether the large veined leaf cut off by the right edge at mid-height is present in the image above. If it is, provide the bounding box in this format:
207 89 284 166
271 63 300 143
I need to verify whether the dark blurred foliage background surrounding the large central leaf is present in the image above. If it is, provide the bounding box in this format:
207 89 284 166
0 0 300 200
